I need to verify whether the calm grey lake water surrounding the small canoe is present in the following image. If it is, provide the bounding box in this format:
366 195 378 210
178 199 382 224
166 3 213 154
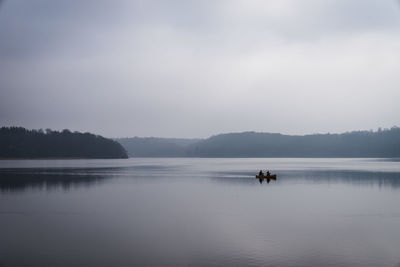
0 158 400 267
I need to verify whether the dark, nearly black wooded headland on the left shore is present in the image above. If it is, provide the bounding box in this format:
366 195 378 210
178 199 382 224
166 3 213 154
0 127 127 158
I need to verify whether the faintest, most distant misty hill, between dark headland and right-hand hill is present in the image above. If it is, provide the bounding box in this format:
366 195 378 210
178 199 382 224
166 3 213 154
115 137 200 157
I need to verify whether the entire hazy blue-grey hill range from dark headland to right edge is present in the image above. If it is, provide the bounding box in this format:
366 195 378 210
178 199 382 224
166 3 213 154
118 127 400 157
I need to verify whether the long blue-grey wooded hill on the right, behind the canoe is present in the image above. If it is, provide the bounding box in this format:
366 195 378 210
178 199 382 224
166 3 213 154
187 127 400 158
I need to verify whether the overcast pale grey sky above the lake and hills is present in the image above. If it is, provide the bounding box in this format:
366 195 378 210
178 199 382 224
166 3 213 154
0 0 400 138
